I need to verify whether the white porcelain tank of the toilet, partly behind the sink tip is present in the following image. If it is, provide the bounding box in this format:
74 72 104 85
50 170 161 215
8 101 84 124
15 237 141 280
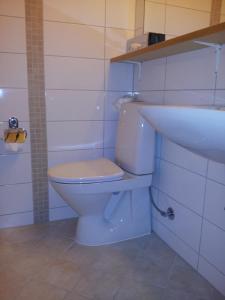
116 102 155 175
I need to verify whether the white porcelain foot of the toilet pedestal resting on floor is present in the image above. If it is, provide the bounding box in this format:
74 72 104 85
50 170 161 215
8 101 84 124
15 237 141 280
75 188 151 246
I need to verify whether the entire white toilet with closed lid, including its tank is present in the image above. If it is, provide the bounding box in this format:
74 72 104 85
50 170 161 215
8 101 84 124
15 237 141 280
48 102 155 246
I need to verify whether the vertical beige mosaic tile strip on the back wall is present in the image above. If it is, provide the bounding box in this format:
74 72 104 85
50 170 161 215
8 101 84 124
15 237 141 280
25 0 49 223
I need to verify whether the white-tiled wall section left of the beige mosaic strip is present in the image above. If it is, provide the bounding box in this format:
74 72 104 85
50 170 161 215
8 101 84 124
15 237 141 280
0 0 33 227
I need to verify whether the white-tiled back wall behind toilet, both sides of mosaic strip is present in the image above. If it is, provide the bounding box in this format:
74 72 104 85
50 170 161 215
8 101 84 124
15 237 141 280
0 0 135 227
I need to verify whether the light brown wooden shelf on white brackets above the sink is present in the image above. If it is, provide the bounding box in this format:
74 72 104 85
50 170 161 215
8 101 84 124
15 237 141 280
111 22 225 63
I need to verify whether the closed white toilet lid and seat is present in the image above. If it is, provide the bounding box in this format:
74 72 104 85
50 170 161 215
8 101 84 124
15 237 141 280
48 158 124 183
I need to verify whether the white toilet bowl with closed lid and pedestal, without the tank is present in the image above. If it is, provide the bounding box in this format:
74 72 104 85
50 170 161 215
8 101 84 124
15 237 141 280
48 158 152 246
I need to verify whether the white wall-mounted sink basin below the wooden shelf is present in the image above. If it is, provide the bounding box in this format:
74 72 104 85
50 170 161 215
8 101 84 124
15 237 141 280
140 105 225 163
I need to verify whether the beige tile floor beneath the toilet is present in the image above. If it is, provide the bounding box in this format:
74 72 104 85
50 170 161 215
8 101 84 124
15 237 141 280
0 220 225 300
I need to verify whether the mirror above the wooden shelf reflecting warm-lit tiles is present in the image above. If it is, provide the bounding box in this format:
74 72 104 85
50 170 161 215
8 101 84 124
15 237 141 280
144 0 218 39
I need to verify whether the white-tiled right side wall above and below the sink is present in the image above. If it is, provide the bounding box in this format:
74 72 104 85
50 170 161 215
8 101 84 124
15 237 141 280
135 47 225 294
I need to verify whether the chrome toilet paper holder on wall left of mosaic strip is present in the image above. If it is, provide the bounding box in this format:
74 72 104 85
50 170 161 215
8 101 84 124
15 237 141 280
2 117 27 144
